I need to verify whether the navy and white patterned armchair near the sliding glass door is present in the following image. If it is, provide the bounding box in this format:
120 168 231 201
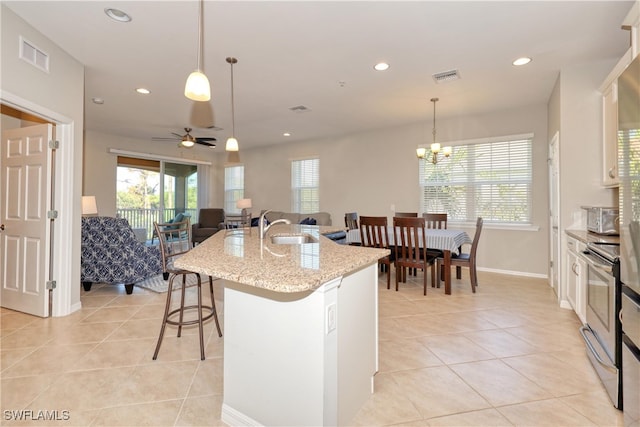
80 216 162 294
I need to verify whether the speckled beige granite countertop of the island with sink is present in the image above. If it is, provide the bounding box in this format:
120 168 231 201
175 224 390 293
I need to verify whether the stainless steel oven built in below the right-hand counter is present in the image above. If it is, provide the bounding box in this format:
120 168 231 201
580 243 622 408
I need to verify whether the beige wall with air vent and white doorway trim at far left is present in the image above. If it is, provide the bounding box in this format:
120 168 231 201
0 5 84 316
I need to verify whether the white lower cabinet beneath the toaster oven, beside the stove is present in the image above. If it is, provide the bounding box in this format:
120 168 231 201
565 236 587 323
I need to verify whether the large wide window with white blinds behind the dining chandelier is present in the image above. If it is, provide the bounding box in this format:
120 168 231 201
419 134 533 225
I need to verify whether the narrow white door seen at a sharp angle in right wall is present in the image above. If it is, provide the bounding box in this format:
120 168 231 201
548 133 560 297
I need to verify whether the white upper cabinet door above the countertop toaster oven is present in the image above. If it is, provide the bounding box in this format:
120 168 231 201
602 80 619 187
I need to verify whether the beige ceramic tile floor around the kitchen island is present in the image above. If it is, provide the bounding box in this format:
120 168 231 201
0 271 623 426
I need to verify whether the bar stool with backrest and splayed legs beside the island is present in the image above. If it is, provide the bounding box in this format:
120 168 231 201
153 218 222 360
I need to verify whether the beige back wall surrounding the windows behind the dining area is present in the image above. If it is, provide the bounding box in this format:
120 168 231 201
229 105 549 277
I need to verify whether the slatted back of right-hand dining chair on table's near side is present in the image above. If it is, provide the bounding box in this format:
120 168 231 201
393 217 427 266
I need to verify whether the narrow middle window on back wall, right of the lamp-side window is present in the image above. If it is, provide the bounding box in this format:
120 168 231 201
291 159 320 213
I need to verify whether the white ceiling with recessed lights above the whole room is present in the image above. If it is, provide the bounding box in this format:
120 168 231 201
3 0 633 150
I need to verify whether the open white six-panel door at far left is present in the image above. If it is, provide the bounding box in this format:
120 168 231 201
0 124 53 317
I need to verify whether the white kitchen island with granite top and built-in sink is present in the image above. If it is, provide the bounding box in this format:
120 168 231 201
176 225 389 426
